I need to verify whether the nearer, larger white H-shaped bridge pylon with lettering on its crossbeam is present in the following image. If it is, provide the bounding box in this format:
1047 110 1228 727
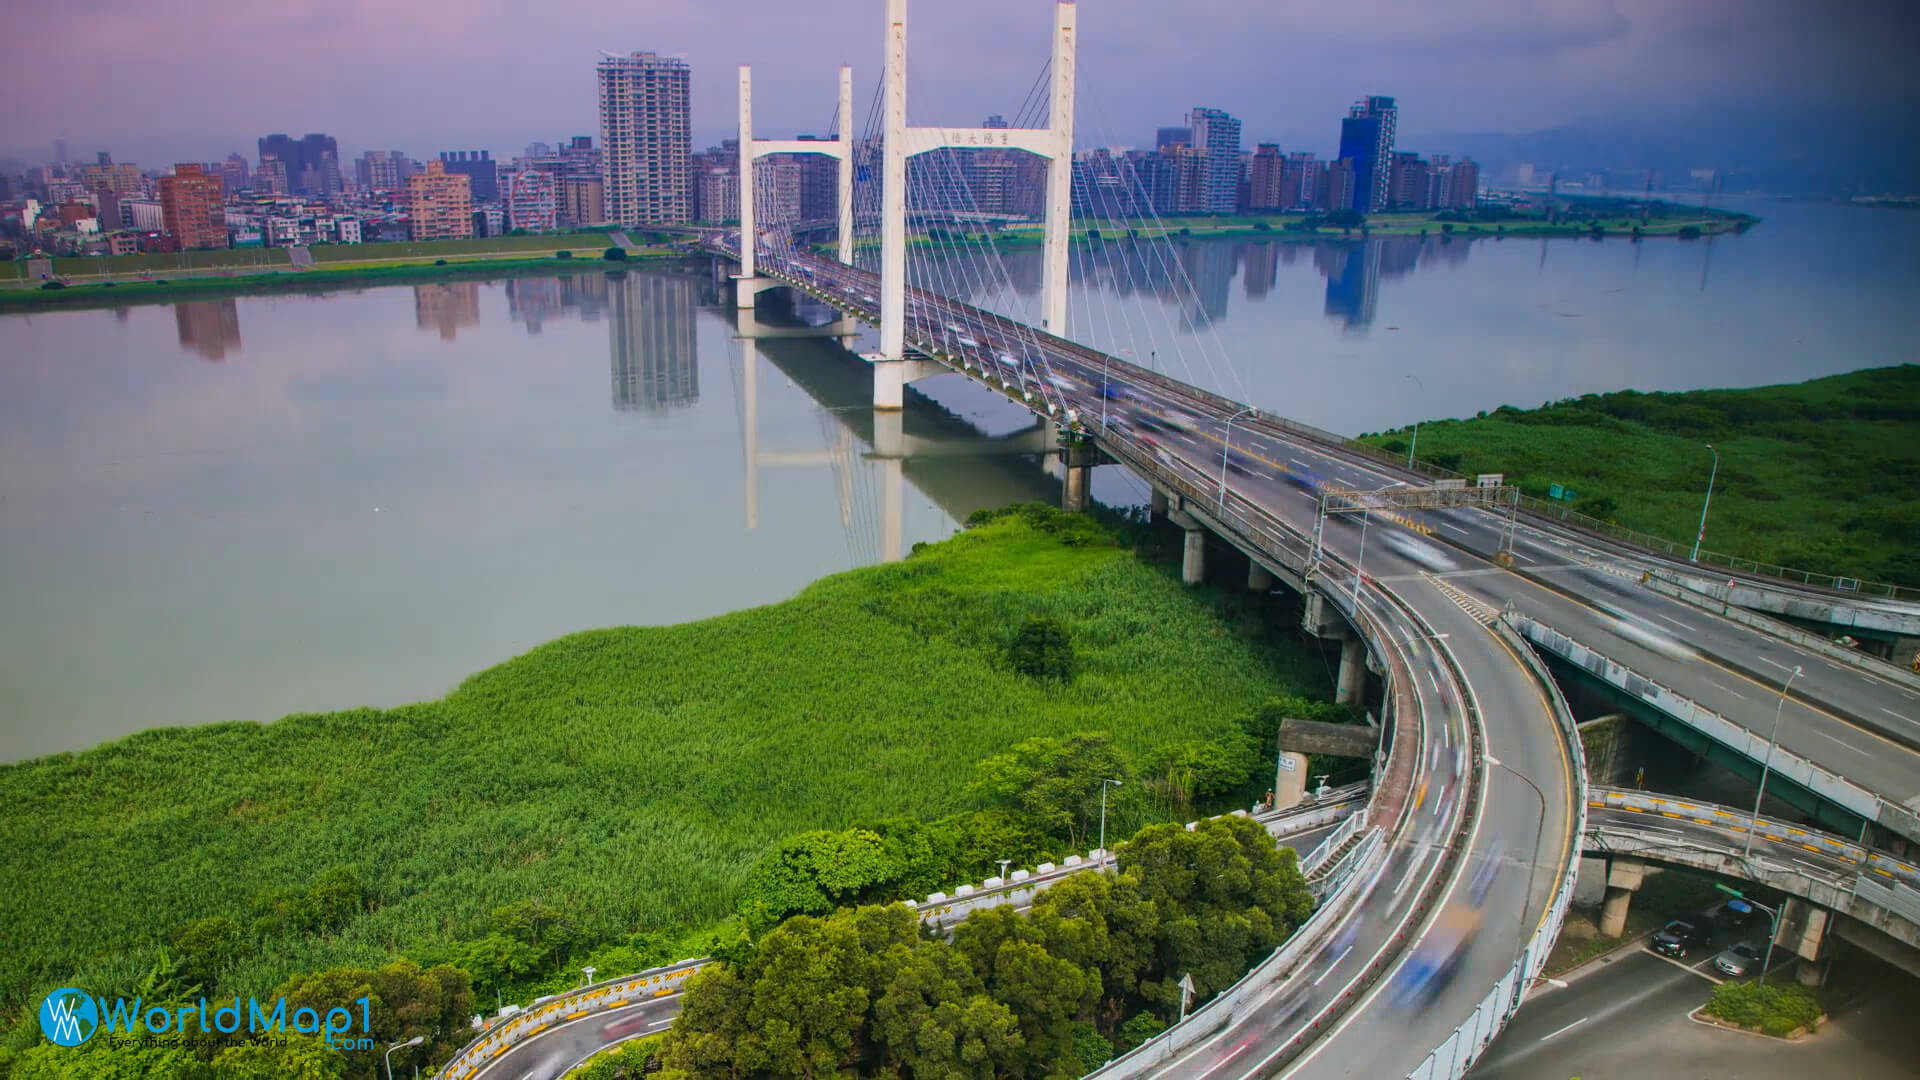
870 0 1075 409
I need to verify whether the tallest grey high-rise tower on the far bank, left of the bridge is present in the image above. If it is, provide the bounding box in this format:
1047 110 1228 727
597 52 698 225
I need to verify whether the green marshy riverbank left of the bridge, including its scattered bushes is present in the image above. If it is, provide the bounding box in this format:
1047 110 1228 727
0 507 1323 1074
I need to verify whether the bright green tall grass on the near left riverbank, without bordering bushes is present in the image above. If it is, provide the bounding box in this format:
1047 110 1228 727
0 517 1325 1009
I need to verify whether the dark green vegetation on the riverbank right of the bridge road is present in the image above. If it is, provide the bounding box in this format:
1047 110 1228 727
1361 363 1920 586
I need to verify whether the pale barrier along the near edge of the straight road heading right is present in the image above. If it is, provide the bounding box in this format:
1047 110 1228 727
1501 613 1920 840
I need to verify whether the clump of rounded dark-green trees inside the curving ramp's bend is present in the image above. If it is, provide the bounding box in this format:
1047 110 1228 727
660 817 1313 1080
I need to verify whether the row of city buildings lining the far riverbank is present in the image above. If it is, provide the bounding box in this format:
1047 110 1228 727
0 52 1480 254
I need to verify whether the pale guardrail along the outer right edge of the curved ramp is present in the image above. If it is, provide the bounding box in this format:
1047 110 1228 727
1407 615 1586 1080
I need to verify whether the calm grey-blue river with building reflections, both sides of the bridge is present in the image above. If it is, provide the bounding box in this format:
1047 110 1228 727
0 202 1920 761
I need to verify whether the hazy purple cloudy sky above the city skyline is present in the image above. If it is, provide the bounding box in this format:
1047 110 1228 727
0 0 1920 165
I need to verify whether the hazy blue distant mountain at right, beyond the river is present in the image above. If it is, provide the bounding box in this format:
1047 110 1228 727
1400 104 1920 196
